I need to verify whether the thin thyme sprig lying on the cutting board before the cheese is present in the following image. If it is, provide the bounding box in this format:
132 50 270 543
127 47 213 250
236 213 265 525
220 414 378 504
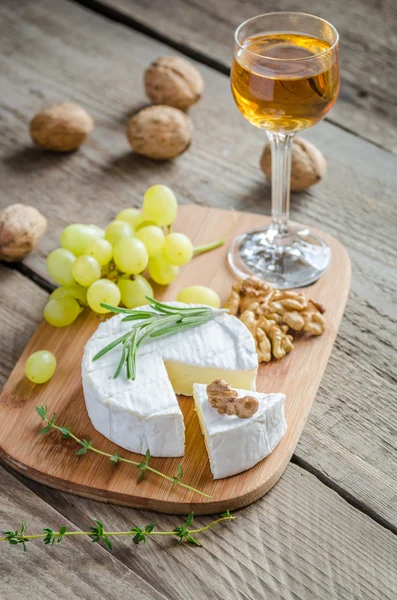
36 406 212 499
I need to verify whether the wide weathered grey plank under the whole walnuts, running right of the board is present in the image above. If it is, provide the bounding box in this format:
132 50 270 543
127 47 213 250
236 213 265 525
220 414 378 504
0 1 397 526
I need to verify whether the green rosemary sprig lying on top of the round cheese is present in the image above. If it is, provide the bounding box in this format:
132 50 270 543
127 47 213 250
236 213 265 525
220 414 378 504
92 296 227 380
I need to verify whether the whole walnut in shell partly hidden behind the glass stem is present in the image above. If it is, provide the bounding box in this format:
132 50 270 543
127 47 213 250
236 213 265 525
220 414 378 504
260 137 327 192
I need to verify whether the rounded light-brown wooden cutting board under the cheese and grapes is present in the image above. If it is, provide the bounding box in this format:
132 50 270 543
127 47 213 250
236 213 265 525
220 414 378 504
0 206 350 514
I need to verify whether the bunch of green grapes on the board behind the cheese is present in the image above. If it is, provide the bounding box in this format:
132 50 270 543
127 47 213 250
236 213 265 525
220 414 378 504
44 185 220 327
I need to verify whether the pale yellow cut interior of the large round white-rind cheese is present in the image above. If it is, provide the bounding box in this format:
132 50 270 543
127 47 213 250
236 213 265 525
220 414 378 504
165 360 256 396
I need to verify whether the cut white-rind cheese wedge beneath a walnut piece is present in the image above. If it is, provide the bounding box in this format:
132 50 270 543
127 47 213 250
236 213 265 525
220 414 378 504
193 379 287 479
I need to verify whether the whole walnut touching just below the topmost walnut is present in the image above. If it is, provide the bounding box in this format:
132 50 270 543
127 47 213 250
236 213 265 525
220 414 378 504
127 106 193 160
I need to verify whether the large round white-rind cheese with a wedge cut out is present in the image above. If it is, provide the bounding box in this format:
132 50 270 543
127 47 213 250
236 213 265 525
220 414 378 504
82 302 258 457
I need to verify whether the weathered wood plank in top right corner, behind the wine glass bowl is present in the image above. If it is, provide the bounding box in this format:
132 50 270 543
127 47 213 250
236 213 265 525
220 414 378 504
93 0 397 152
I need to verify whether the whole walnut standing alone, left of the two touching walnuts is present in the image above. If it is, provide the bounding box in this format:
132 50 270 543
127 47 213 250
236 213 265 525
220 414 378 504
30 102 94 152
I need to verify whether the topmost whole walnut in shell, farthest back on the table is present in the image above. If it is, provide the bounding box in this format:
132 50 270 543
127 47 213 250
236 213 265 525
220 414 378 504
144 56 204 110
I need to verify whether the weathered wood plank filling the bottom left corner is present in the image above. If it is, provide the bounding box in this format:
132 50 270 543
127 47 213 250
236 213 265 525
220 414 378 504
0 467 169 600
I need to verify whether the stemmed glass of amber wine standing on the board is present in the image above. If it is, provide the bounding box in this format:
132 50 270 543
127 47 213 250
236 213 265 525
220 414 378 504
228 12 339 288
